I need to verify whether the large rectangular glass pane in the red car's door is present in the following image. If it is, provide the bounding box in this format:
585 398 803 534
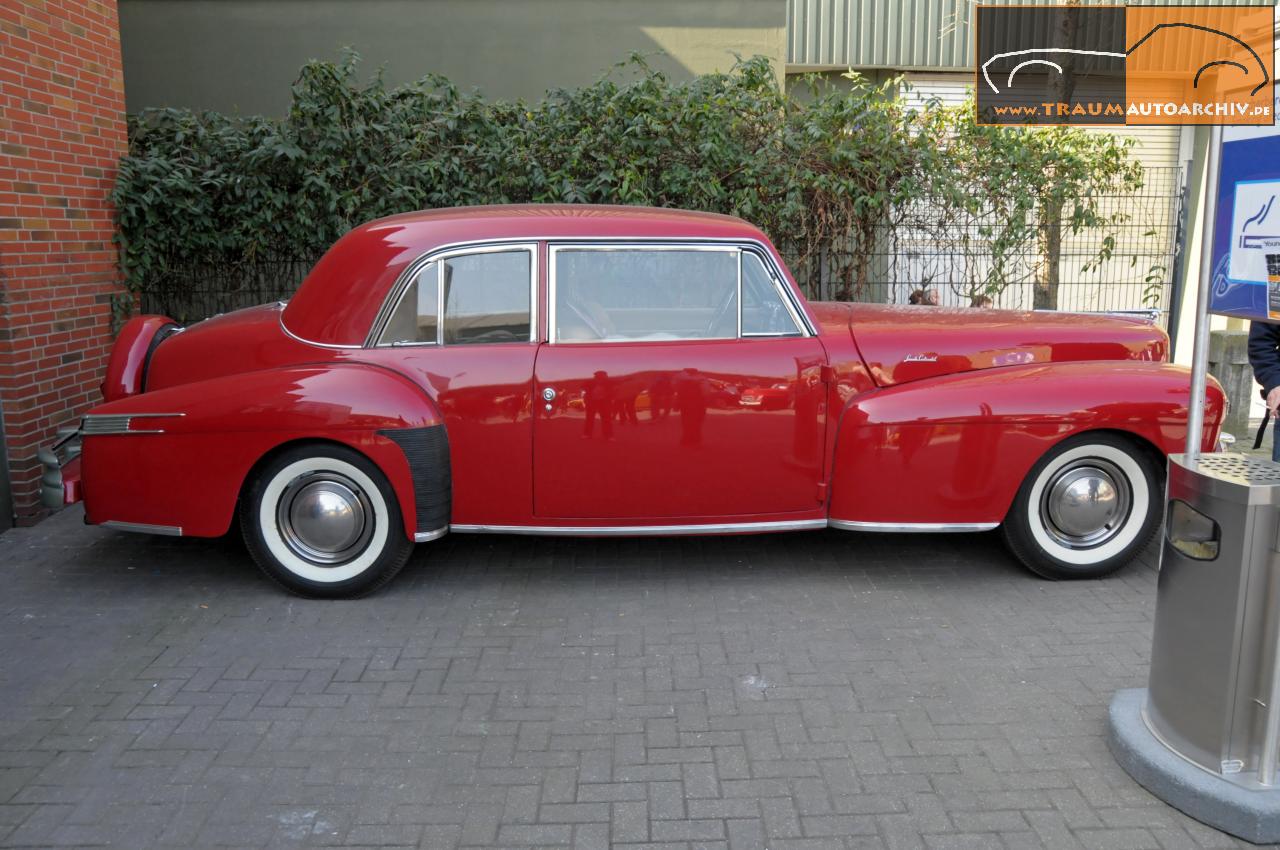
554 248 739 342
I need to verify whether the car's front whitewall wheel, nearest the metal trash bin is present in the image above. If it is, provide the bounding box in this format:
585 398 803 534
1001 434 1162 579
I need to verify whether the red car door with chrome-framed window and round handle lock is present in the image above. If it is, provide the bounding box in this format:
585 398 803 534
534 243 826 525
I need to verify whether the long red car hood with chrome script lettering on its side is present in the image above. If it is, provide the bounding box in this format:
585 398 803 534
813 303 1169 387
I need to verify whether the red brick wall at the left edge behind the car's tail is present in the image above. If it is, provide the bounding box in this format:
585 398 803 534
0 0 127 527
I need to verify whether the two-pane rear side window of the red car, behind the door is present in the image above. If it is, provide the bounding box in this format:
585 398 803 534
378 248 532 346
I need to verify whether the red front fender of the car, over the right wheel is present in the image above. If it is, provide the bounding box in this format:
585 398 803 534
831 361 1224 524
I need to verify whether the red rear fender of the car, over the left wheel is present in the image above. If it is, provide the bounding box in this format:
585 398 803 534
79 364 442 538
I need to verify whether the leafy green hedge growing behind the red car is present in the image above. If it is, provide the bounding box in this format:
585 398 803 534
113 52 1142 312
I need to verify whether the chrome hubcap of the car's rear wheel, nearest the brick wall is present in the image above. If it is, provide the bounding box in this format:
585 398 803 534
275 472 374 567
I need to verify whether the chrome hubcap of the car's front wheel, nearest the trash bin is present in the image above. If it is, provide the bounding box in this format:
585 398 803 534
1039 457 1132 549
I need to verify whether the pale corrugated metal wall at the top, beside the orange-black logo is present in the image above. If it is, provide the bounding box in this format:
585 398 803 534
787 0 1274 70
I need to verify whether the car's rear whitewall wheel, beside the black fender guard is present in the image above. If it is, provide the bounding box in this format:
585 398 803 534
241 444 413 599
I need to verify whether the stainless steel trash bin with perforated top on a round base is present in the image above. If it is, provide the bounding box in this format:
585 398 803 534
1143 453 1280 790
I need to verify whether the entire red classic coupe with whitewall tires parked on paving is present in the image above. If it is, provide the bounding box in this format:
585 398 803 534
52 206 1224 597
